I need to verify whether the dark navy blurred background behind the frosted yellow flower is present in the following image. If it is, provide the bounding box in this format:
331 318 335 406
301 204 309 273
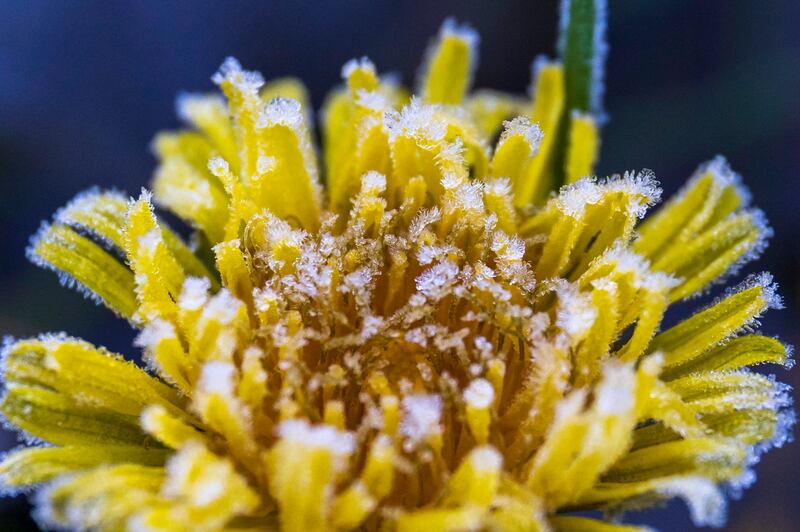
0 0 800 531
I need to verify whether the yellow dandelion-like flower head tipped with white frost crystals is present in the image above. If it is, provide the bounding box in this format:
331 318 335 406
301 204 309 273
0 2 792 531
